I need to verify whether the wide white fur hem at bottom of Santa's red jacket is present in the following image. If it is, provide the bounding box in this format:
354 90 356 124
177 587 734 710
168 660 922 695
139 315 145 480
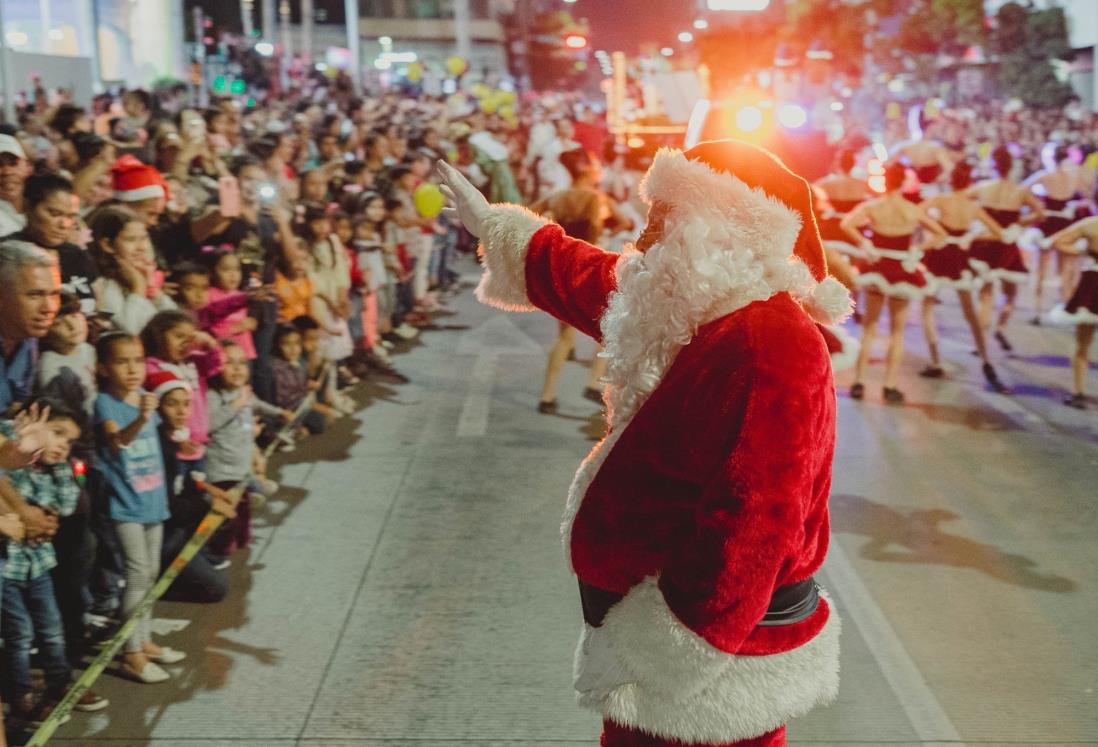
576 577 841 744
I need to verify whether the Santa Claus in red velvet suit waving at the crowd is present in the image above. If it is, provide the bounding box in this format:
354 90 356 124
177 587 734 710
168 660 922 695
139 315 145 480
439 141 851 747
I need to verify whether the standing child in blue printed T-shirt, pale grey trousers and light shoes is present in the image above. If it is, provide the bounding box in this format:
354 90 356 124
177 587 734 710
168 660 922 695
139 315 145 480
96 336 183 683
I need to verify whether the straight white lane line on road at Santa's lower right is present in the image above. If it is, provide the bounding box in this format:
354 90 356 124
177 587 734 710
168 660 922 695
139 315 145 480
824 538 965 745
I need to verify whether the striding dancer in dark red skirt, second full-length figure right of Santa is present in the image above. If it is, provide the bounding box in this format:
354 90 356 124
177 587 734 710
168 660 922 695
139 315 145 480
920 160 1008 393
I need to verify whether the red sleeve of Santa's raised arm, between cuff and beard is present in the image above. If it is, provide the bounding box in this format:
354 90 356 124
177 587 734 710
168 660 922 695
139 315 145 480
526 223 619 341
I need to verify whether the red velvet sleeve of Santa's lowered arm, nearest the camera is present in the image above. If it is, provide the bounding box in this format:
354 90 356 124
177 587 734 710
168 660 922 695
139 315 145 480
660 311 834 653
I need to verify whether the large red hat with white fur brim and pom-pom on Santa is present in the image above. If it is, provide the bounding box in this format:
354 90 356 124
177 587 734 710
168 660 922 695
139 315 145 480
641 140 852 324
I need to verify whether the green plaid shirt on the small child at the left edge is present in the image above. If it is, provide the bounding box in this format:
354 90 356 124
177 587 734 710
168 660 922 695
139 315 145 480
0 426 80 581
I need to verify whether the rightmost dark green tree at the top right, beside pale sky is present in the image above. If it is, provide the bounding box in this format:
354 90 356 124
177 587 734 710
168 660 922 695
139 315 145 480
991 2 1072 108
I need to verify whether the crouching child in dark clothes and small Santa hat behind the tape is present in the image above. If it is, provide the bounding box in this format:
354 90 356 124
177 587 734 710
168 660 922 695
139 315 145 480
148 371 236 603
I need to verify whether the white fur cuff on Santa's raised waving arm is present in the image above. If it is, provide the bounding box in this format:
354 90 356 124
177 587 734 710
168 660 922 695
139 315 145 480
475 204 549 311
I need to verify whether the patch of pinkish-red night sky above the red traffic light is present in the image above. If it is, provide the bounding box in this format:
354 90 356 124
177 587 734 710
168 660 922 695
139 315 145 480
561 0 697 52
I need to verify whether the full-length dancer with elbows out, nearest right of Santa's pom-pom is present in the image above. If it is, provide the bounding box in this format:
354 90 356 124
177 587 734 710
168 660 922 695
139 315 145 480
842 163 948 404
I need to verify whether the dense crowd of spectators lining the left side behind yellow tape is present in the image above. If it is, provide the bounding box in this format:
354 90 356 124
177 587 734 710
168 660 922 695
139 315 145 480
0 71 610 744
